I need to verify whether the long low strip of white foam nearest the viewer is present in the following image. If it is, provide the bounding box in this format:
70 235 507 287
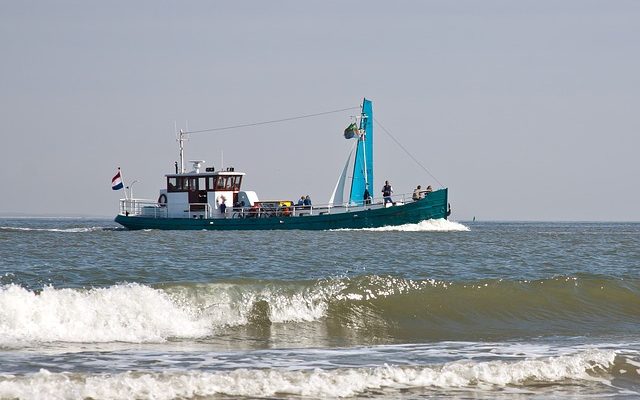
0 350 615 399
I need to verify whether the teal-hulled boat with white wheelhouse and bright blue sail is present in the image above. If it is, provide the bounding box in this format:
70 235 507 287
115 99 451 230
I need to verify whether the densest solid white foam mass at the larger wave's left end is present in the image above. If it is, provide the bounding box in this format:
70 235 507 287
0 284 208 344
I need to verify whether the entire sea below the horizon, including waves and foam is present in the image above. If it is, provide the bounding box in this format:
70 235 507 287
0 218 640 399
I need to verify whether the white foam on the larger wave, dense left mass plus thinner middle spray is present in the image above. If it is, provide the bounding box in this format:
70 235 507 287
0 284 340 345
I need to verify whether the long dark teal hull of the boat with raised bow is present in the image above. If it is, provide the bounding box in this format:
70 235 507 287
115 189 448 230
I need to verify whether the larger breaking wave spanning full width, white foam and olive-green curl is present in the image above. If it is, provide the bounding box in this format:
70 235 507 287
0 275 640 346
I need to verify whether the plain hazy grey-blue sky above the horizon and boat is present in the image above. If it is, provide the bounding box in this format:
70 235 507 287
0 0 640 221
